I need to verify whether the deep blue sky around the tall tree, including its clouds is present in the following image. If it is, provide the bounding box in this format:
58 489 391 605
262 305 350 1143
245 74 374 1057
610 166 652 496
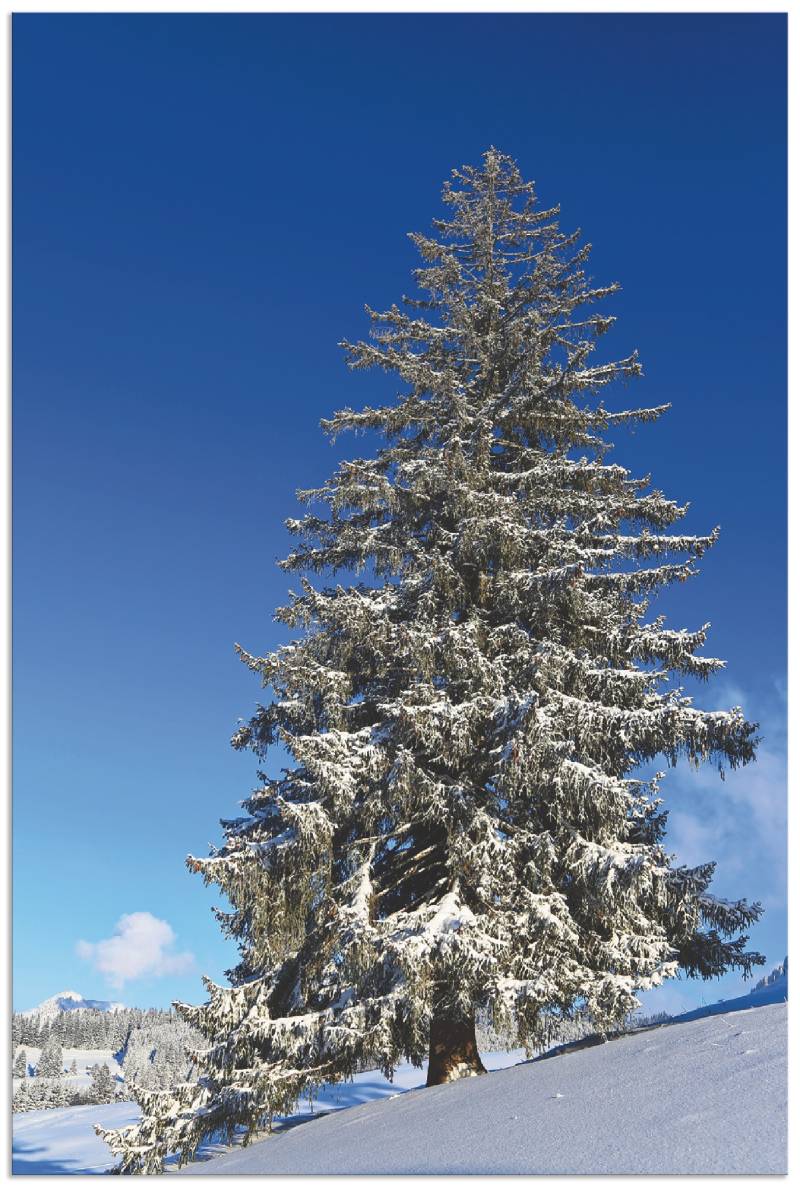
13 14 786 1009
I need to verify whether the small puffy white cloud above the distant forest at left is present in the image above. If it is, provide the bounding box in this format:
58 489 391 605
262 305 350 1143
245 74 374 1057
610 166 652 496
76 910 195 989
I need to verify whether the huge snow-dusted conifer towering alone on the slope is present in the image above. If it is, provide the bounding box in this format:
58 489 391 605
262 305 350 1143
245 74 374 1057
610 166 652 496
99 150 762 1172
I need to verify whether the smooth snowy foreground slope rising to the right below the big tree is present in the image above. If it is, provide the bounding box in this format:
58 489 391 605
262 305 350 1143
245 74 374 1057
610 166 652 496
183 1004 787 1175
